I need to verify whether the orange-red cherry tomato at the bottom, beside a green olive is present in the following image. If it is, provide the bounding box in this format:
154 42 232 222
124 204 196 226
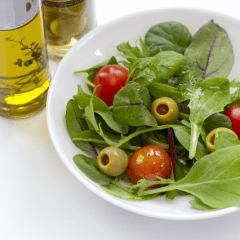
127 145 172 183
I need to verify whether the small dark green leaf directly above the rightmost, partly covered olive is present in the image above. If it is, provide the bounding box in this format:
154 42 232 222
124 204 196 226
203 112 232 133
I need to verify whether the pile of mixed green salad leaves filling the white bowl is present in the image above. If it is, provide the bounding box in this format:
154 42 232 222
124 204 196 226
66 21 240 210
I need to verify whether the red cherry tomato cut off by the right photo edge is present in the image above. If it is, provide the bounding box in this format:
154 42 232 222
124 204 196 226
225 104 240 139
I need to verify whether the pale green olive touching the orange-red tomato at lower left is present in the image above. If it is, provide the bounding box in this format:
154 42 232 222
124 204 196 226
97 147 128 177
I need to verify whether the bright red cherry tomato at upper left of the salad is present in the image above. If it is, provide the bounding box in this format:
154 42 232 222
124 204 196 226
93 64 128 106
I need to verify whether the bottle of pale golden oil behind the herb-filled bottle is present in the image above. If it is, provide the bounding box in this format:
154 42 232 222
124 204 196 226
42 0 96 60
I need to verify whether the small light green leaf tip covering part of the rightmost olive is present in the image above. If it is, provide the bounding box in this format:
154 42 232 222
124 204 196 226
214 131 240 150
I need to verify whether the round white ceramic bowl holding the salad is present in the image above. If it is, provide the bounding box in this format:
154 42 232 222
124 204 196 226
47 8 240 220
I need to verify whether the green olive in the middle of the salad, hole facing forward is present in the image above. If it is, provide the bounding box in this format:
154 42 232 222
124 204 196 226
151 97 179 124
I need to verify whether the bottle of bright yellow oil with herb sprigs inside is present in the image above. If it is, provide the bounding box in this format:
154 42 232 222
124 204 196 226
0 0 50 119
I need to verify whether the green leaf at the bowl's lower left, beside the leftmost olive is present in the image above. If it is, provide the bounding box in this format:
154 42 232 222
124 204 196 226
73 154 113 184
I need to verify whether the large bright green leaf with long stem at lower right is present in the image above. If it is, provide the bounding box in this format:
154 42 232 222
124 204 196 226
139 145 240 209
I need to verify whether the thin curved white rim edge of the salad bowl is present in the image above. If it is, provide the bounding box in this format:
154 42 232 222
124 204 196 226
46 7 240 221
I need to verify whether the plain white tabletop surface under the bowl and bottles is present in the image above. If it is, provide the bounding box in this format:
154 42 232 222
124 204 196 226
0 0 240 240
